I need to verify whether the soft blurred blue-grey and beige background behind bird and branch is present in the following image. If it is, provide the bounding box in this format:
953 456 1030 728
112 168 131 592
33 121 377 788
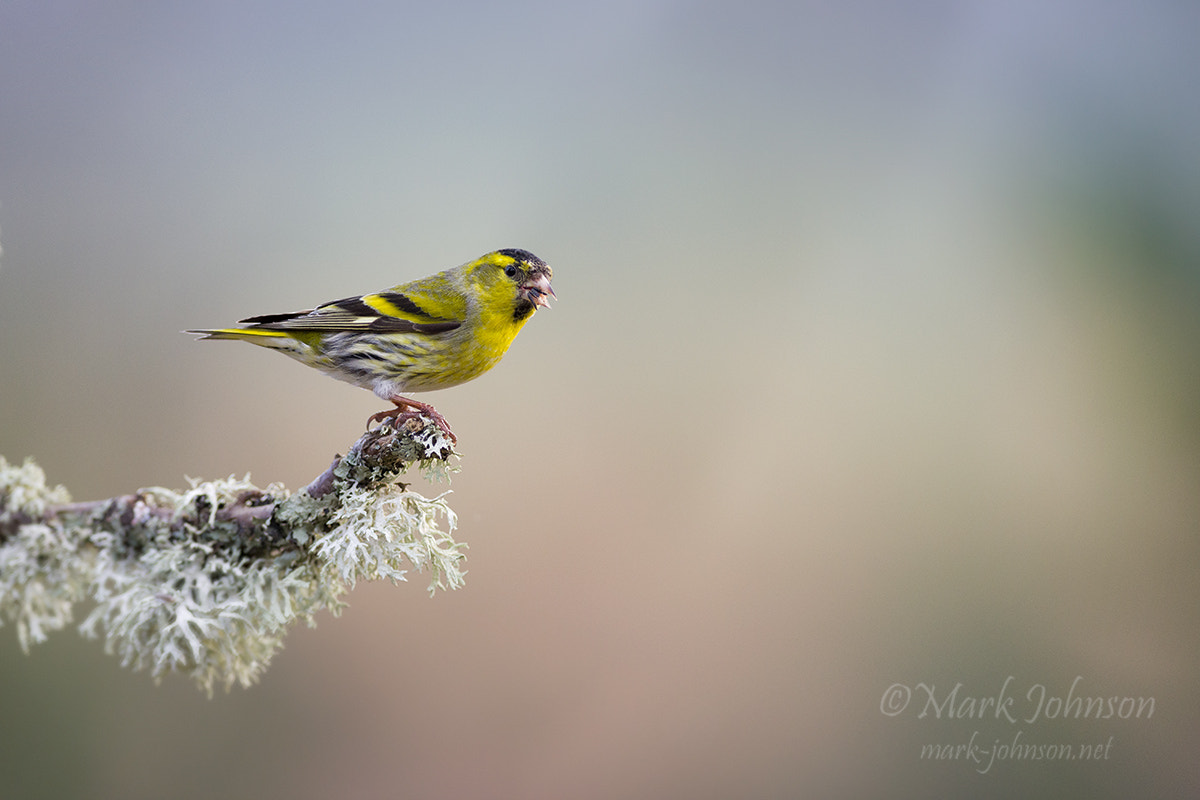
0 0 1200 799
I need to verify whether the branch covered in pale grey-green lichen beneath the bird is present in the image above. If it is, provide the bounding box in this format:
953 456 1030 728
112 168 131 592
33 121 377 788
0 417 466 694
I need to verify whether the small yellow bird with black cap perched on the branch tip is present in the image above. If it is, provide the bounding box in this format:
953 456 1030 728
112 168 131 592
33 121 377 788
187 248 557 441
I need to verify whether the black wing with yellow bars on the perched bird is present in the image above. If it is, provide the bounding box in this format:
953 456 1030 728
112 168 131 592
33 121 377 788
241 291 462 333
